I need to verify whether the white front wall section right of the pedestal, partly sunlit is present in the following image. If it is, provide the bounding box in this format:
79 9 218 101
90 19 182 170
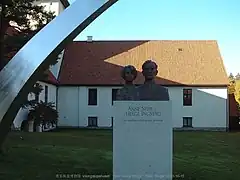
169 87 227 128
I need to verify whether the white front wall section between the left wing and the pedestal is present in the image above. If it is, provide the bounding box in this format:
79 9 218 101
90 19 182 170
58 87 119 127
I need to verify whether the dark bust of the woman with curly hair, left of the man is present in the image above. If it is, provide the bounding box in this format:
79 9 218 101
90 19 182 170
116 65 137 101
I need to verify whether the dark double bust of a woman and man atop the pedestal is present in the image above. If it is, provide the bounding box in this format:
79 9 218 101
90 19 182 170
116 60 169 101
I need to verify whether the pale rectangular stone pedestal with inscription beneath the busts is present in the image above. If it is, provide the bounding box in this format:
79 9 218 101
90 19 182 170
113 101 173 180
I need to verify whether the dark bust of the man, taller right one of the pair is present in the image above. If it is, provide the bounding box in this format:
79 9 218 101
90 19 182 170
136 60 169 101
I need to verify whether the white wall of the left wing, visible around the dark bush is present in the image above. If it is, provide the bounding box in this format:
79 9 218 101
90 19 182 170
13 82 57 128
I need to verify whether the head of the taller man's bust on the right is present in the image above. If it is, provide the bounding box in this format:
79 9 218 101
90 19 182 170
142 60 158 82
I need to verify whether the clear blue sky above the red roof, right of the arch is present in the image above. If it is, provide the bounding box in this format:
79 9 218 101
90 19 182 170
69 0 240 74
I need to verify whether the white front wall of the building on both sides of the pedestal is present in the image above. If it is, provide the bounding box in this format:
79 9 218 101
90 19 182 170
58 87 227 128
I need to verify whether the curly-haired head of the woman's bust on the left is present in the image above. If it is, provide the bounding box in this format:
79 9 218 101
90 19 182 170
121 65 137 84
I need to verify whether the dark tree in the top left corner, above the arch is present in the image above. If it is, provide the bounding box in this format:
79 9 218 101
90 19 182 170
0 0 57 70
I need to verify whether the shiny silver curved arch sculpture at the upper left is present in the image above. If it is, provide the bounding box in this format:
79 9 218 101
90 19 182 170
0 0 118 145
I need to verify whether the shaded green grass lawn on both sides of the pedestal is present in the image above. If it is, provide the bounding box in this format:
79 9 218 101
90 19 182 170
0 130 240 180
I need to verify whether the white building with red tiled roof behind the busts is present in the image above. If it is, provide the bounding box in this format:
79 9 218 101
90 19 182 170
11 0 228 130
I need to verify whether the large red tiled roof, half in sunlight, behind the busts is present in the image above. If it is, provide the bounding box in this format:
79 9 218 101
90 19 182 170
58 41 228 86
